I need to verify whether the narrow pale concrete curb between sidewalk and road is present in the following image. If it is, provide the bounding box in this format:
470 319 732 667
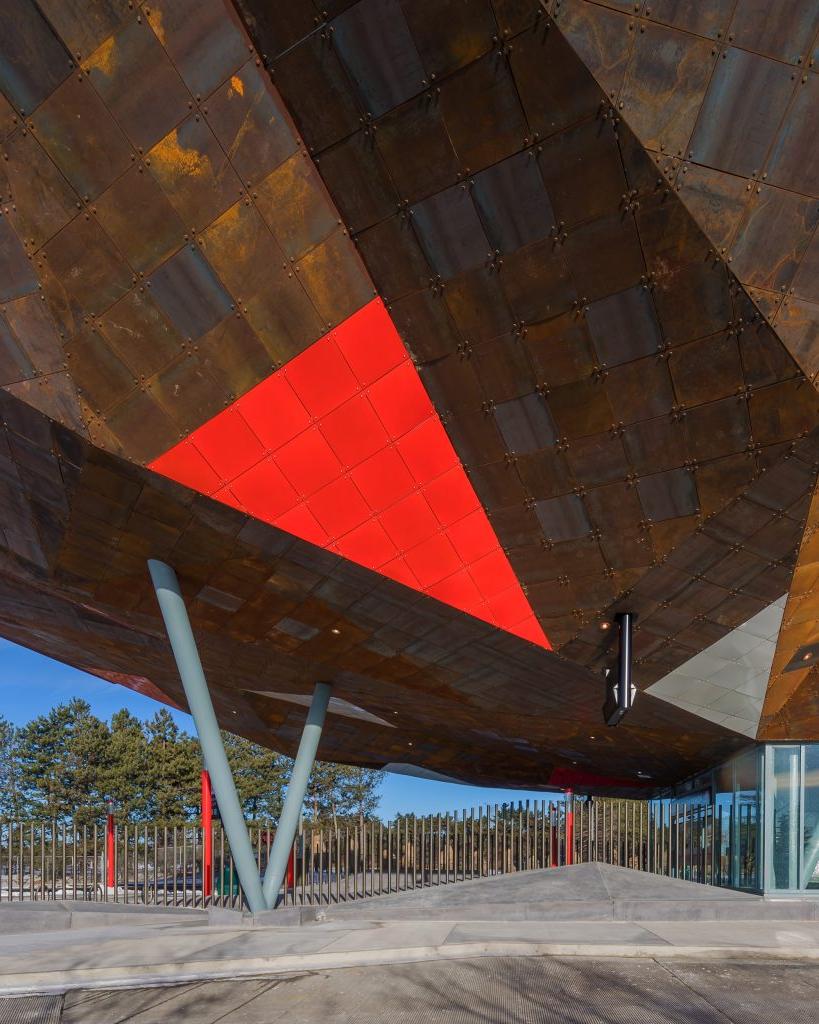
0 941 819 996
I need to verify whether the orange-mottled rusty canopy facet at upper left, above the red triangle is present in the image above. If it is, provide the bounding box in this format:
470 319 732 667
0 0 374 461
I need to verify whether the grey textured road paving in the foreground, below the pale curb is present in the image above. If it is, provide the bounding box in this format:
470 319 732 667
0 957 819 1024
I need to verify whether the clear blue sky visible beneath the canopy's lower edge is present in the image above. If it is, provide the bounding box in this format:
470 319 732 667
0 639 554 818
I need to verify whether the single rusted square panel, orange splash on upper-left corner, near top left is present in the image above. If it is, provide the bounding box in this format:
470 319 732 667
78 16 191 151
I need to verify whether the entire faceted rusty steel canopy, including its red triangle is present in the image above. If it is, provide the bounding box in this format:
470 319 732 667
0 0 819 788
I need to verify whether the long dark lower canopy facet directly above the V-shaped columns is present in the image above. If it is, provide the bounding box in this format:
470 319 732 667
0 385 744 793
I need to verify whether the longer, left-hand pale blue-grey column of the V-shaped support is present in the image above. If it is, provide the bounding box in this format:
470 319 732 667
147 558 265 913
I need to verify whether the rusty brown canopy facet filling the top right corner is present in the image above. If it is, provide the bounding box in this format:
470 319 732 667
550 0 819 423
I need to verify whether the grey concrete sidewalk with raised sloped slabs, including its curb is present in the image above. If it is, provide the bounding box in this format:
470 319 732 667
0 865 819 994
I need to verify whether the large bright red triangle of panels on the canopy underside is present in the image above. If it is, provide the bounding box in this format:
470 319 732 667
152 299 549 647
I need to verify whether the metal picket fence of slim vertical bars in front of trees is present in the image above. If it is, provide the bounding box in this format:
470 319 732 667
0 799 756 907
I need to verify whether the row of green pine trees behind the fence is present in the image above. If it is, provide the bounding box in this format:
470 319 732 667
0 698 383 825
